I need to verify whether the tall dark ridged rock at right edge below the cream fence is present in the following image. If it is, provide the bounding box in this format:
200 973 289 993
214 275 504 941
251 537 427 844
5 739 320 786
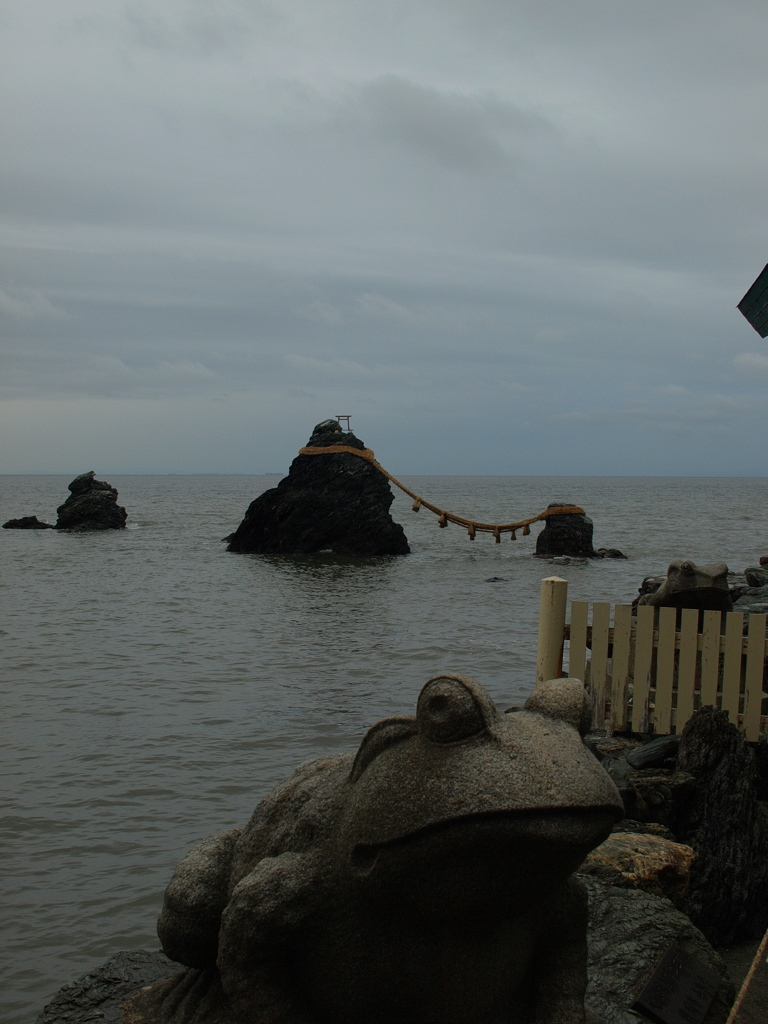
669 708 768 945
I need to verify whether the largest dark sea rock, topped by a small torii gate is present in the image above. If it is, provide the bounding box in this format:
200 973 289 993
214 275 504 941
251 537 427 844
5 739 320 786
227 420 410 555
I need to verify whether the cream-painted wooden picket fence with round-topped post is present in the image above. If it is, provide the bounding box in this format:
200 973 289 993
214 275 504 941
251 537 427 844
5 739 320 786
537 577 768 741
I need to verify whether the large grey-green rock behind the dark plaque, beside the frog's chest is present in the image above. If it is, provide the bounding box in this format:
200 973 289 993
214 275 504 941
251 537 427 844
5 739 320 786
582 877 734 1024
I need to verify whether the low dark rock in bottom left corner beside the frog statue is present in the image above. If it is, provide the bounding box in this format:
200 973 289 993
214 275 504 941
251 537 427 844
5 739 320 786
36 949 178 1024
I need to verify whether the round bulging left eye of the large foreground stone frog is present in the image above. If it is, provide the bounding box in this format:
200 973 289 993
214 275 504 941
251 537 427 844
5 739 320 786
416 676 499 743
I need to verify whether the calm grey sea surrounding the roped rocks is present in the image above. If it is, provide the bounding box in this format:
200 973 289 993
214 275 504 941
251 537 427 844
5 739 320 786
0 473 768 1024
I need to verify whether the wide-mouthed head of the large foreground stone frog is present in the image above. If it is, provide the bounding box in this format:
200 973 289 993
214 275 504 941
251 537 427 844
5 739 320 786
338 676 624 915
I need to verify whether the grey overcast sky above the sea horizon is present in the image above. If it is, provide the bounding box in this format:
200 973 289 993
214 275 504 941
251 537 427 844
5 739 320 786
0 0 768 478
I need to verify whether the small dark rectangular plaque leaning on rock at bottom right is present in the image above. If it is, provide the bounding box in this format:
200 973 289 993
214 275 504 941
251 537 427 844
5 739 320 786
632 942 721 1024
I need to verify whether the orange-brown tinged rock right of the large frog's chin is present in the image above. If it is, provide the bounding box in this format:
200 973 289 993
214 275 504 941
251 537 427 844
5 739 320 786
579 831 694 904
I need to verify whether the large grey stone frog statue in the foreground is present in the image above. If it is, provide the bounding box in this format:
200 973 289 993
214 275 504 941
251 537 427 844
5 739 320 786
126 676 623 1024
